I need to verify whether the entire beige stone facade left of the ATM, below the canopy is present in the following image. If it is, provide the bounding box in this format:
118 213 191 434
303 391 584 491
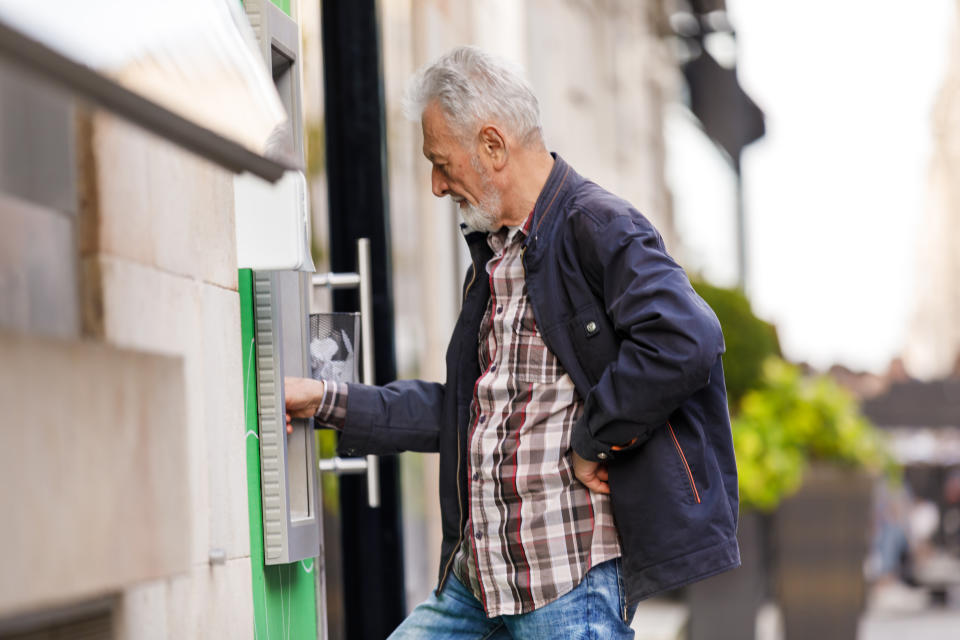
0 69 254 639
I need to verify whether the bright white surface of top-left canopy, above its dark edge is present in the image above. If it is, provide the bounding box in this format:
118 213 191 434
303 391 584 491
0 0 300 179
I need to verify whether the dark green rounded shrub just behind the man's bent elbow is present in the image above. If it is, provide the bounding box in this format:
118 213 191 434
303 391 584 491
693 281 780 413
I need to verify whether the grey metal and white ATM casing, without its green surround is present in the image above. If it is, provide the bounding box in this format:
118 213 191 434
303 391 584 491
235 0 323 565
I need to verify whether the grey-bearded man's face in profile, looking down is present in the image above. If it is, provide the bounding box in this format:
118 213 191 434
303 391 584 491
422 103 502 231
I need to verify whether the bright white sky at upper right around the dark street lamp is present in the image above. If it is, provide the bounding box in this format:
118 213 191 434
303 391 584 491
667 0 954 372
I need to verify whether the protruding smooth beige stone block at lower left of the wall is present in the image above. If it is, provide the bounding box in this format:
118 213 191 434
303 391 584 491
0 332 190 618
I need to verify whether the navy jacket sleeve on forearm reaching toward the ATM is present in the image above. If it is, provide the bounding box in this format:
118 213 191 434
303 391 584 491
337 380 445 456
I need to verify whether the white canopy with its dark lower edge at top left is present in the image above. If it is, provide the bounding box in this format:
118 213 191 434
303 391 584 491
0 0 302 181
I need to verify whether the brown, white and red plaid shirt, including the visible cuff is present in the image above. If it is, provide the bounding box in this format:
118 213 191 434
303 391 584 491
317 219 620 617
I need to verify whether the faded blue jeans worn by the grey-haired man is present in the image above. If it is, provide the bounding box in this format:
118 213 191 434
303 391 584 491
390 559 636 640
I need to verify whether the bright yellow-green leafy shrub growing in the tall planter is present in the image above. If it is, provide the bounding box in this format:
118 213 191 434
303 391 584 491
732 358 897 511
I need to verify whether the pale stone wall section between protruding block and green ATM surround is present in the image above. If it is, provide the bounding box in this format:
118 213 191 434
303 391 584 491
78 113 253 638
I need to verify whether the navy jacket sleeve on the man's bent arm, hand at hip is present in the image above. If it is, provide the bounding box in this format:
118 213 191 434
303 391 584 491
572 210 724 460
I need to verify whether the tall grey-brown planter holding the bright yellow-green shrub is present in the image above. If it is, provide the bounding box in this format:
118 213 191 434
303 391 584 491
773 464 873 640
